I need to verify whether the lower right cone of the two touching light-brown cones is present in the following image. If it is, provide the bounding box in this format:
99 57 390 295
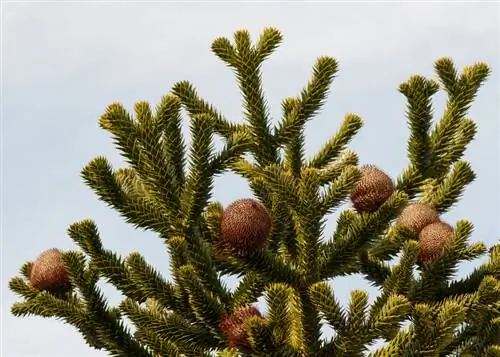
418 222 453 265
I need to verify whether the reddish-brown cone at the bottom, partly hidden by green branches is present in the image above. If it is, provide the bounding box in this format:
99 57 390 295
220 306 265 348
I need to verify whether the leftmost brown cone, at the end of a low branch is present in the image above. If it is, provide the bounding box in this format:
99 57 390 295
29 248 71 294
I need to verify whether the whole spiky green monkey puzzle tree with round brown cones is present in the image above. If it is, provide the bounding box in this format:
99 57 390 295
10 28 500 357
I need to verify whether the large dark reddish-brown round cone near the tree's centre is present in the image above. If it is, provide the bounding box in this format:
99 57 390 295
216 198 272 256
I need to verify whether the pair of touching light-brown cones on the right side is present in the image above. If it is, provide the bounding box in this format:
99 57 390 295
396 203 453 264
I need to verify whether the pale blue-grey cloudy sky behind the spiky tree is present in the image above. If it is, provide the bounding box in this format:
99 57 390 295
1 1 500 357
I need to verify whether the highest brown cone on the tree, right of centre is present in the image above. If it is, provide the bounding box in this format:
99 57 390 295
350 165 395 213
